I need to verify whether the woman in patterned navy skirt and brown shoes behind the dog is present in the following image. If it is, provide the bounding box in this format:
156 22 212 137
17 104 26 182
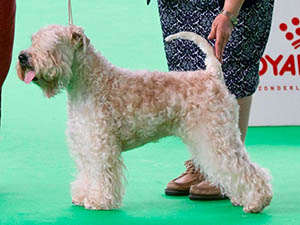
147 0 274 200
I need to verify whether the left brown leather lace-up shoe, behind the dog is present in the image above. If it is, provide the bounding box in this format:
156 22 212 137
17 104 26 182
165 160 204 196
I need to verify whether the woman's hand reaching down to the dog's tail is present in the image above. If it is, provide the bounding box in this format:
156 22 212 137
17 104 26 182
208 14 233 63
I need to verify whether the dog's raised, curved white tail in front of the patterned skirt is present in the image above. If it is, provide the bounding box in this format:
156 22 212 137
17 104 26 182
165 32 223 79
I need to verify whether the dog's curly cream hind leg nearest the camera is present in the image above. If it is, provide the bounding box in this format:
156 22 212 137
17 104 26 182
185 107 272 212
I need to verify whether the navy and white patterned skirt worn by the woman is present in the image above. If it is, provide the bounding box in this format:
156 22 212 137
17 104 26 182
158 0 274 98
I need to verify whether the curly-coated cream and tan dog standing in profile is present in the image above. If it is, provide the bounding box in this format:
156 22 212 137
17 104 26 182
17 25 272 212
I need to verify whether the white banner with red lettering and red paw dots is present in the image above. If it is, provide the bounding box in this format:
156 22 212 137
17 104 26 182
250 0 300 126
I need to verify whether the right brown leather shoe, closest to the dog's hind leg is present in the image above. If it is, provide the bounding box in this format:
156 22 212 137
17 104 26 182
189 181 228 200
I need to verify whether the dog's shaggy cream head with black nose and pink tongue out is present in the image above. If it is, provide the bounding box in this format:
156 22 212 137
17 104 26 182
17 25 89 98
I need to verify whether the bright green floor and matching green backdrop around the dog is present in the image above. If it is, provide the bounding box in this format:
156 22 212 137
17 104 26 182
0 0 300 225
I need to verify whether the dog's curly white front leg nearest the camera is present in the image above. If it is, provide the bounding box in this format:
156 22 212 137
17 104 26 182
84 137 124 210
